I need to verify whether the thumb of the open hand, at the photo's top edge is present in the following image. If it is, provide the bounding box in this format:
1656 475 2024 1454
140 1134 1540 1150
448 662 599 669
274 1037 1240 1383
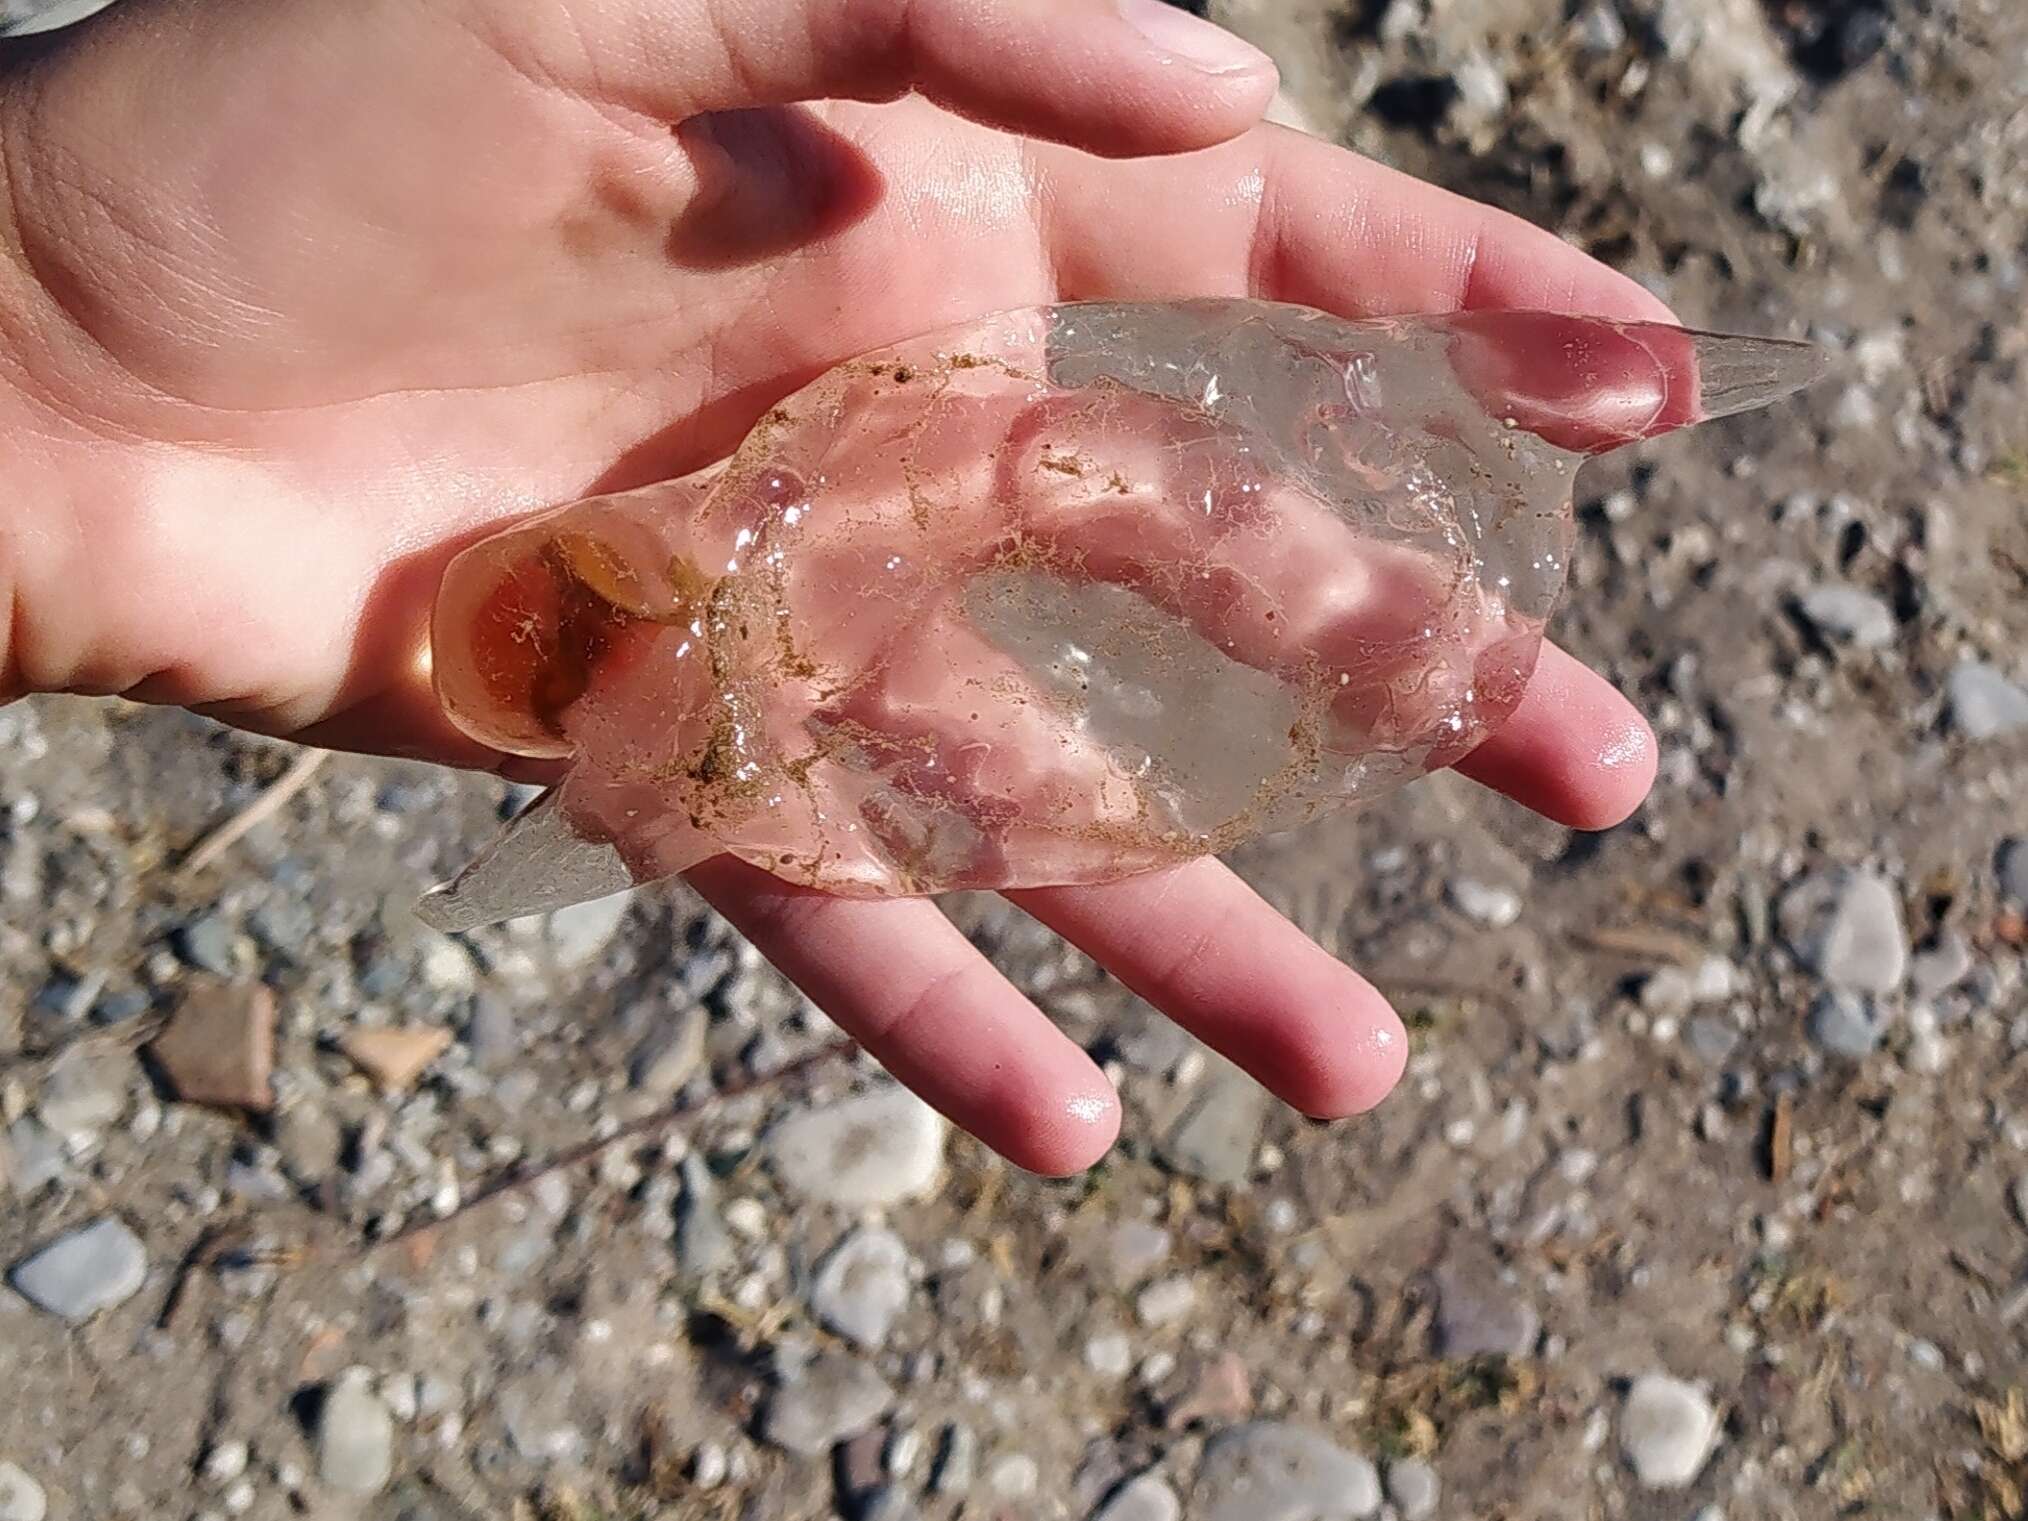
489 0 1276 156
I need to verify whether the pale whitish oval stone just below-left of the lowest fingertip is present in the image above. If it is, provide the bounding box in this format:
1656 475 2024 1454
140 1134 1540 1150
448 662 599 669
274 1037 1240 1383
767 1083 945 1209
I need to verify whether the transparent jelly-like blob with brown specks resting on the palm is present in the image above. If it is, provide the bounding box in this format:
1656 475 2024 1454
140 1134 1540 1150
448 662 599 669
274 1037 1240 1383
422 300 1821 929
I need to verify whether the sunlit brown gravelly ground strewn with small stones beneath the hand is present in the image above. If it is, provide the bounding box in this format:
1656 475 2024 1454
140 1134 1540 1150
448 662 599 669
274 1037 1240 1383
0 0 2028 1521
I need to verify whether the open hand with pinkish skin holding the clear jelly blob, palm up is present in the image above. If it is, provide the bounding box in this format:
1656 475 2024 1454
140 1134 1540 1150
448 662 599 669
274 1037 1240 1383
0 0 1667 1172
